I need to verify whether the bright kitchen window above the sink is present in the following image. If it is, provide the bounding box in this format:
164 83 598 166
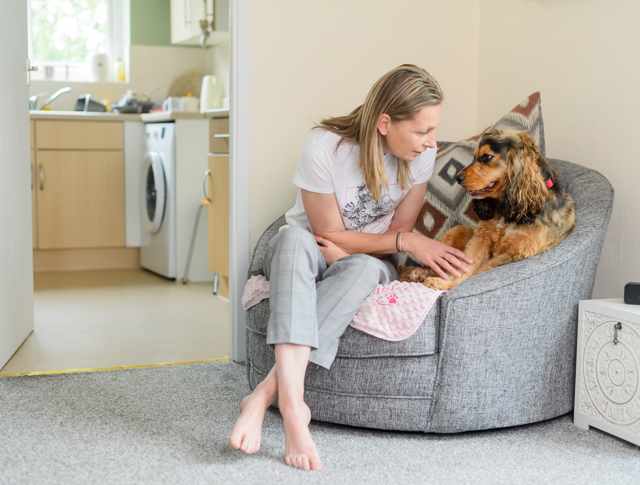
28 0 130 82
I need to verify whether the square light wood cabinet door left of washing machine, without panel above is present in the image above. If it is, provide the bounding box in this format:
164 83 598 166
37 150 125 249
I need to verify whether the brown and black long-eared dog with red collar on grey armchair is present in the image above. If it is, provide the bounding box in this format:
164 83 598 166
398 130 576 290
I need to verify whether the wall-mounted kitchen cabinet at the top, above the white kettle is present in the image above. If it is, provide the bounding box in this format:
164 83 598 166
171 0 229 45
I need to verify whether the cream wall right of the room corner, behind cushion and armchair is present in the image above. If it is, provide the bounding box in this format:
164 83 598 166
477 0 640 298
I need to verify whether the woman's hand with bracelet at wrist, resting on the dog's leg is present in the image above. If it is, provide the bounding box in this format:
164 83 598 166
402 232 473 280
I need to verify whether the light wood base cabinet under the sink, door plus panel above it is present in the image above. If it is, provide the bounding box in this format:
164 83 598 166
32 120 125 250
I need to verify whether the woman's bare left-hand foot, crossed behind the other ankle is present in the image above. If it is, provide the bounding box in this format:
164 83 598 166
229 386 275 454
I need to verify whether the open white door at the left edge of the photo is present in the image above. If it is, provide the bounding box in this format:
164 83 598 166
0 0 33 368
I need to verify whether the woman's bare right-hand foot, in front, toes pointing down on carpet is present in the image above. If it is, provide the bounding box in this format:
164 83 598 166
280 403 322 470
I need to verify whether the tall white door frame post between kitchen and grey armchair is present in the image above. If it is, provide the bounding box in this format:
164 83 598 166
229 0 251 362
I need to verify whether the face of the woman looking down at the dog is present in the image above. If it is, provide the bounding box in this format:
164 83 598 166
378 104 442 162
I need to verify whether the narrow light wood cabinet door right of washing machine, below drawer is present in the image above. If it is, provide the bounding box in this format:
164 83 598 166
207 155 229 277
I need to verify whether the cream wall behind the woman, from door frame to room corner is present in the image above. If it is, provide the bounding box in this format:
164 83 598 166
250 0 480 249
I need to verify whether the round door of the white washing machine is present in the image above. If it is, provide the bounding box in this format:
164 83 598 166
140 151 167 234
